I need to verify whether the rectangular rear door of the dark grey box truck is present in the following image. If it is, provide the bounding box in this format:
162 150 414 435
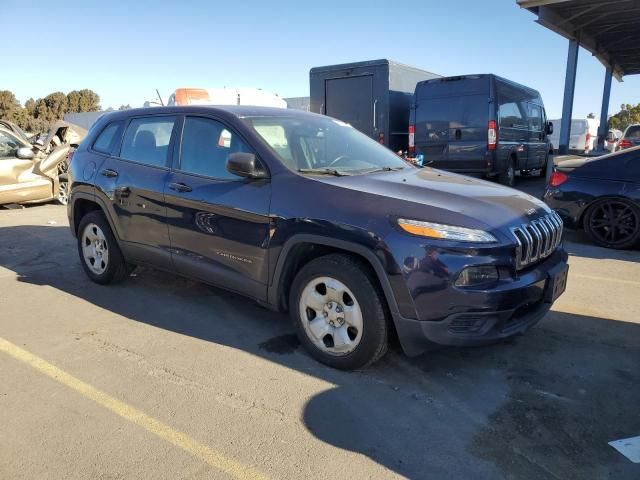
325 75 374 137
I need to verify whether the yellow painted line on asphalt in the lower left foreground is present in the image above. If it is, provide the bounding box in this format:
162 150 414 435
0 337 267 480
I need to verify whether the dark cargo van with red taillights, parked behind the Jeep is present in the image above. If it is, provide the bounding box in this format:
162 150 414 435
409 75 553 185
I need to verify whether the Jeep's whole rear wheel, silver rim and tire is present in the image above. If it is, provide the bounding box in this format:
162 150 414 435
78 210 131 285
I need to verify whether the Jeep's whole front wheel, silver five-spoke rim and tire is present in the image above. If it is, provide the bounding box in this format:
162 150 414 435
289 254 388 370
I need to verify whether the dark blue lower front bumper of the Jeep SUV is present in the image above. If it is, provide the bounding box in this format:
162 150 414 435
394 249 568 356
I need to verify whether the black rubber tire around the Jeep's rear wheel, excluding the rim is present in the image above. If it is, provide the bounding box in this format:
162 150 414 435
77 210 132 285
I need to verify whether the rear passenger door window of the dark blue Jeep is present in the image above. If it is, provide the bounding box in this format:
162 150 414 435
120 117 176 167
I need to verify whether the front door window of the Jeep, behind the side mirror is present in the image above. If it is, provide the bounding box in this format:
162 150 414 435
180 117 251 179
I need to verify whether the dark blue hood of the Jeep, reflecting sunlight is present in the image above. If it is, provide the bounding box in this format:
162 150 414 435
321 168 549 230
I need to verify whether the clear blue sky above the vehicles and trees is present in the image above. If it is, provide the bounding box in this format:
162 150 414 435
0 0 640 118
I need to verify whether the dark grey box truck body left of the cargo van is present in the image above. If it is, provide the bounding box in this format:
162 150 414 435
309 59 439 152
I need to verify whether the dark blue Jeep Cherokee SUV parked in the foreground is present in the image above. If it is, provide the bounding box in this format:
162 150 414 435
68 106 568 369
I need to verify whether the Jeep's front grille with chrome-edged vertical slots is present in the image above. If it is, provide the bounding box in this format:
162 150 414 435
511 212 562 270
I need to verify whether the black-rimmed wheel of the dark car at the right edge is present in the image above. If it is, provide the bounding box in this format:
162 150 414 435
583 198 640 249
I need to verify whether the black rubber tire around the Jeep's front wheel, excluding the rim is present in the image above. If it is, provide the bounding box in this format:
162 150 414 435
289 254 388 370
